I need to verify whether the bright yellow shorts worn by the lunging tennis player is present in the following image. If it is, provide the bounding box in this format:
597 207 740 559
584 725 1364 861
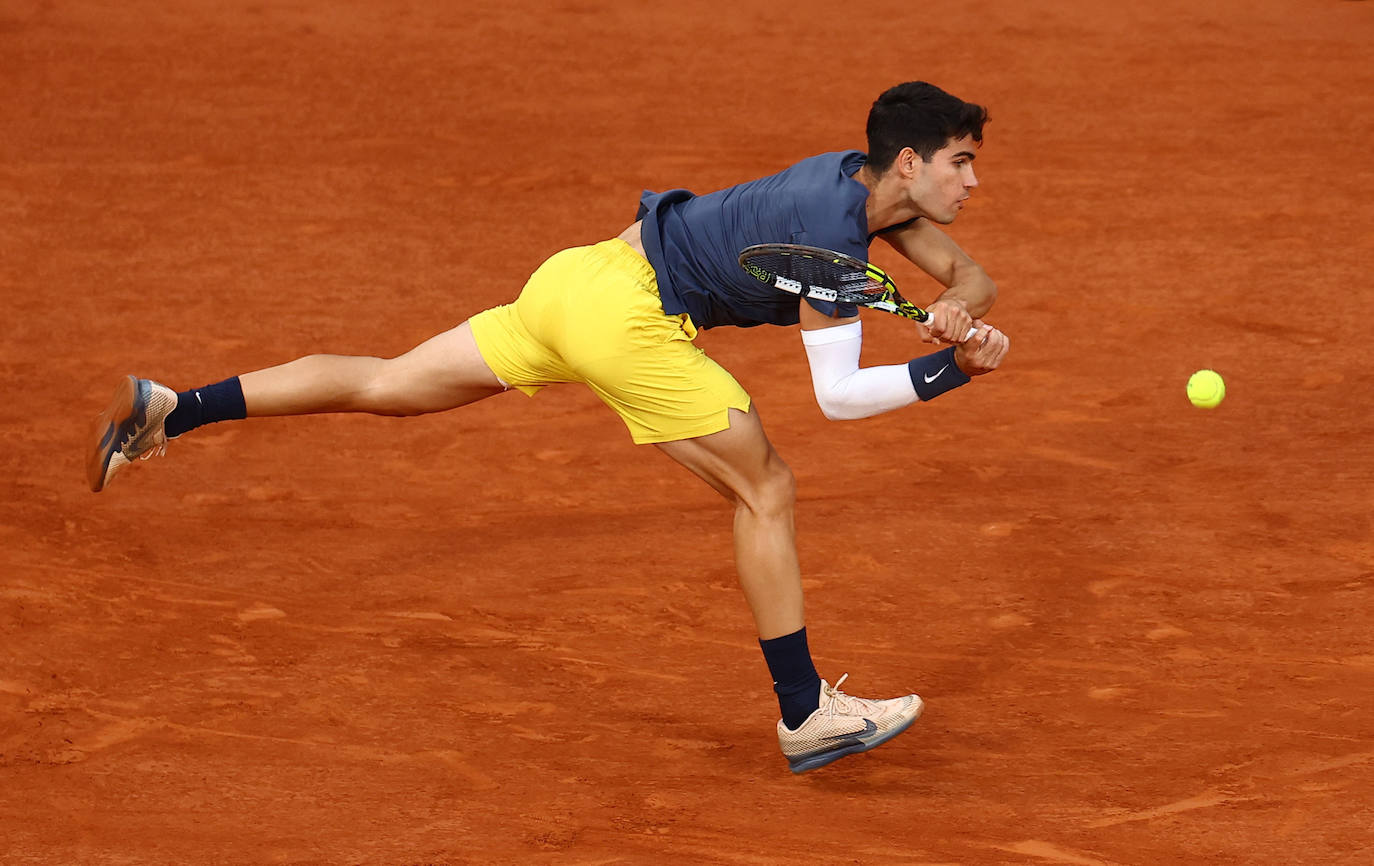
470 241 749 444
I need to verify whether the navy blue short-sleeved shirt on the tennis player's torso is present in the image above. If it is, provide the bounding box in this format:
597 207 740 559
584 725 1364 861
638 150 868 329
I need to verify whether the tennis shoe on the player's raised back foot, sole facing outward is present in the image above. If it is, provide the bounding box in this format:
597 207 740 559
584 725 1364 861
87 375 176 493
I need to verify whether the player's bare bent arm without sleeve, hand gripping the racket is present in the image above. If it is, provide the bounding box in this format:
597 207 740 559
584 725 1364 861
881 220 998 342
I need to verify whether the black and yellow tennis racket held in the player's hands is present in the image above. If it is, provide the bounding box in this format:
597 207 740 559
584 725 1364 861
739 243 977 340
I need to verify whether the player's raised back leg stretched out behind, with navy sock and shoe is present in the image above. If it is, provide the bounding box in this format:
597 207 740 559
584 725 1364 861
87 323 503 491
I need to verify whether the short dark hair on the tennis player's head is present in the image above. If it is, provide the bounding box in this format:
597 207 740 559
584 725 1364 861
868 81 988 175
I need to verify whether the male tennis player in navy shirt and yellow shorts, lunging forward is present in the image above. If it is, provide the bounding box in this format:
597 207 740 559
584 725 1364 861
87 82 1009 773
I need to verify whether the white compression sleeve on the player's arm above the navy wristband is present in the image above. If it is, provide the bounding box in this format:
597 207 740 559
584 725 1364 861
801 322 916 421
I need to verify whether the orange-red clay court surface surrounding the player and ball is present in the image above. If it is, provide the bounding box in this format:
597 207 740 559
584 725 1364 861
0 0 1374 866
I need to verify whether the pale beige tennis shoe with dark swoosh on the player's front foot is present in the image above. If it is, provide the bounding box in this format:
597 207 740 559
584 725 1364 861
778 674 925 773
